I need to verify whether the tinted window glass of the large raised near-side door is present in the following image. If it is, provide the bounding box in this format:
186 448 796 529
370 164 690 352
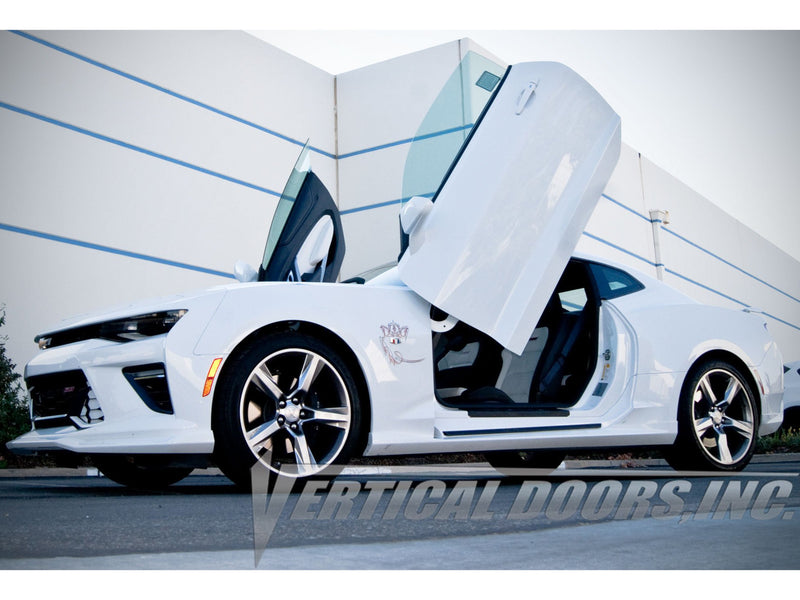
401 52 506 202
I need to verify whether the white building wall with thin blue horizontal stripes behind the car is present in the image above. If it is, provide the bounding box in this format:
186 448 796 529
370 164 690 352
0 31 800 368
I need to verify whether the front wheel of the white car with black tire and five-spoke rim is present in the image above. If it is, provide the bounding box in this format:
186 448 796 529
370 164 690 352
212 332 361 489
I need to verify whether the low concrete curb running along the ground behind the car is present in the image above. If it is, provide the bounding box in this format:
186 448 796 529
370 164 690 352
0 452 800 478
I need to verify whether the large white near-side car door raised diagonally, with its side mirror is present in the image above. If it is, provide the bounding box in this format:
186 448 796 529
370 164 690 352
398 62 620 354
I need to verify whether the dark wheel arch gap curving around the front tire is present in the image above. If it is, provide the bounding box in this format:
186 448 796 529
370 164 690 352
212 320 372 453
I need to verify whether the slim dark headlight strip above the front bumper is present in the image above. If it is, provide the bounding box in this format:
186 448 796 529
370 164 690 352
34 308 187 349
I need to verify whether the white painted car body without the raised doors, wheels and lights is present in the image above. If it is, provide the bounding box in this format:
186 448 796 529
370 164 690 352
6 255 782 454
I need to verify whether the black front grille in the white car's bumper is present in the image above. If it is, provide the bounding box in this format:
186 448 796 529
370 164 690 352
25 370 103 429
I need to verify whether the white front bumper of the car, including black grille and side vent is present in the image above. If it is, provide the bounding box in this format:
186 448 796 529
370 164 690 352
8 294 224 454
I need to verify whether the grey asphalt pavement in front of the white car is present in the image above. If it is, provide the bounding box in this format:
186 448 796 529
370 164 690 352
0 455 800 570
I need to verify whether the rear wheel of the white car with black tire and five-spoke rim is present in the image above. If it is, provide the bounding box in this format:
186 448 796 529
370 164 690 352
664 360 759 471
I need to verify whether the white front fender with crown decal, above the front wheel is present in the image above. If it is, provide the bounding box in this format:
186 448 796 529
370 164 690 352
194 284 433 448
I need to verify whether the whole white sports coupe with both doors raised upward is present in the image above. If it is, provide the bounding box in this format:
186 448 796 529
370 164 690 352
9 58 783 486
